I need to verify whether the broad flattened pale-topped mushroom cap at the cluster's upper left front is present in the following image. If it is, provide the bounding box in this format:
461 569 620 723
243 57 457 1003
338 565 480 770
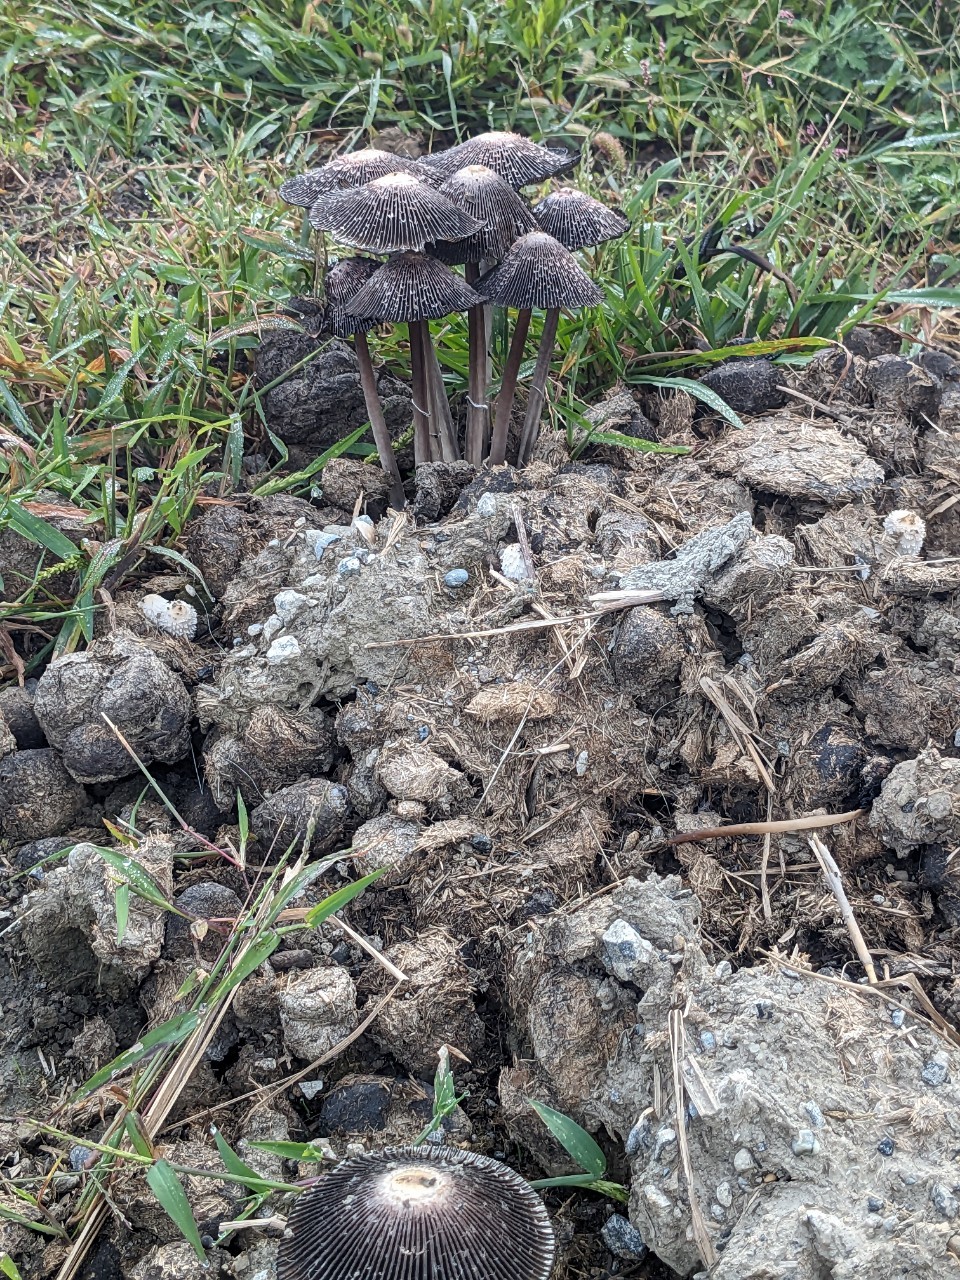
310 173 483 253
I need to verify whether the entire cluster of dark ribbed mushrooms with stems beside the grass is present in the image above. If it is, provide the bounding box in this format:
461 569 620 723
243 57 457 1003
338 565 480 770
280 133 628 494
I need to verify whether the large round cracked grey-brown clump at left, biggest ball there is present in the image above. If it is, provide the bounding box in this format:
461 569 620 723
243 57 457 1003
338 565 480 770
35 631 192 783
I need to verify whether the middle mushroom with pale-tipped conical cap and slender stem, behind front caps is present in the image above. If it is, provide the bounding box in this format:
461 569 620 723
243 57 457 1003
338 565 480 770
430 164 536 466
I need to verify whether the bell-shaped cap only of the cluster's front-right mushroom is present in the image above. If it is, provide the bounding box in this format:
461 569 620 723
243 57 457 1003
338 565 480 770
476 232 603 310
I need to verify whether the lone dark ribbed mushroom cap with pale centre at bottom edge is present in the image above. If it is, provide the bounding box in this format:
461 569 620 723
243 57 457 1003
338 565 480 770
276 1147 554 1280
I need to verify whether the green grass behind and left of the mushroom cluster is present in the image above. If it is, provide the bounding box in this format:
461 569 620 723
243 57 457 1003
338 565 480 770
0 0 960 675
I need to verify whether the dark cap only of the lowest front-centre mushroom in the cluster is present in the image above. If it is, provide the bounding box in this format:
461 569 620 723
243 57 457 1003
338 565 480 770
349 252 484 321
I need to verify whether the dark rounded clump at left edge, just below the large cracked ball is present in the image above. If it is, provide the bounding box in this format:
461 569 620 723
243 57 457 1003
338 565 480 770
0 748 87 844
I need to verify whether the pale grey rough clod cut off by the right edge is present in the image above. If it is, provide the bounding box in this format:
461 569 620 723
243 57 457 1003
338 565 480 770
870 748 960 856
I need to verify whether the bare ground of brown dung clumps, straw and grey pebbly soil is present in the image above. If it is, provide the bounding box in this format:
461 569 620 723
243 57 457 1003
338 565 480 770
0 330 960 1280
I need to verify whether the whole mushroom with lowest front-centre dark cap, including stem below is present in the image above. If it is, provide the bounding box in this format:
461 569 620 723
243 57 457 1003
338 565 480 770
349 253 483 466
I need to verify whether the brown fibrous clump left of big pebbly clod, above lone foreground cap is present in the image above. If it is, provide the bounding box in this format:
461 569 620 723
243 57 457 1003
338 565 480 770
370 929 485 1079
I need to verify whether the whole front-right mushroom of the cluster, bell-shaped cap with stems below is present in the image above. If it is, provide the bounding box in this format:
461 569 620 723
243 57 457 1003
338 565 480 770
476 232 603 465
